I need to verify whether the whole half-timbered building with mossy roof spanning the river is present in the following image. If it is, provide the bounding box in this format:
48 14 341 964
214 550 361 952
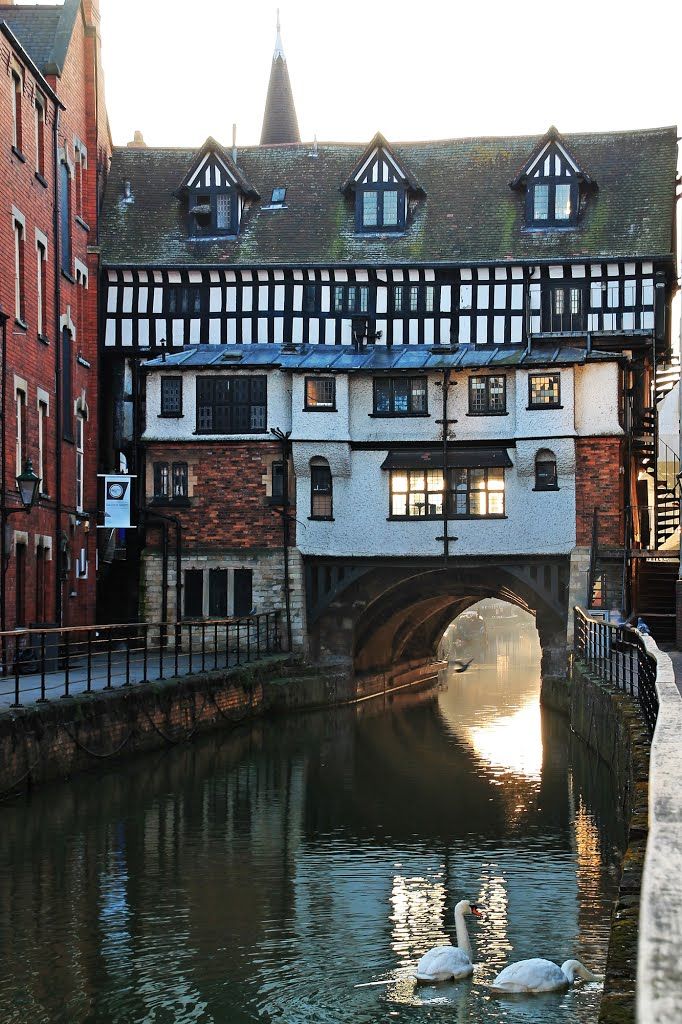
96 24 677 670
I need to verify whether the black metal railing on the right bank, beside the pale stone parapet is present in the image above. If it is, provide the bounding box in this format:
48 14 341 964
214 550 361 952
573 607 658 736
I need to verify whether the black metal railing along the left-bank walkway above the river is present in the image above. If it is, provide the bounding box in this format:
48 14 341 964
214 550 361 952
0 610 282 708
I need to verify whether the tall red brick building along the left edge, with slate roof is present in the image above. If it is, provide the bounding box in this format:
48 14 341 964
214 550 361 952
0 0 107 629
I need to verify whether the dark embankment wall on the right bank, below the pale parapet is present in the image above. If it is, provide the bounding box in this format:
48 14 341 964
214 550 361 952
570 664 649 1024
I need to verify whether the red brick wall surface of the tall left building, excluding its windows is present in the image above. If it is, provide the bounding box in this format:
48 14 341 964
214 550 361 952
0 3 111 628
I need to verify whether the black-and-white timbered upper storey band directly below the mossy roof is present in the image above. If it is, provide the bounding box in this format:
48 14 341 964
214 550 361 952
103 260 663 355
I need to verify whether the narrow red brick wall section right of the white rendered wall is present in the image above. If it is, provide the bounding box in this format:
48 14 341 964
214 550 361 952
576 437 625 547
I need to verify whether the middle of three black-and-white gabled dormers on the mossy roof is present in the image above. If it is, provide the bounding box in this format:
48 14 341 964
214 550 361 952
341 132 424 233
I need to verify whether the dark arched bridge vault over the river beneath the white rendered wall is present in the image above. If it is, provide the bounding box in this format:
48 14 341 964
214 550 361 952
305 555 569 691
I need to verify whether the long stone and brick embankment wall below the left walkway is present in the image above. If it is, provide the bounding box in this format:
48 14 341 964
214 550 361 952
0 655 442 795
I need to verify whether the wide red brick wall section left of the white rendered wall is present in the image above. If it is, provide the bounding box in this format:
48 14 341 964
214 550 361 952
145 441 295 552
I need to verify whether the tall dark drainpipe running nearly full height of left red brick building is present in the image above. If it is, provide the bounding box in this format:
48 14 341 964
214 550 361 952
52 105 63 626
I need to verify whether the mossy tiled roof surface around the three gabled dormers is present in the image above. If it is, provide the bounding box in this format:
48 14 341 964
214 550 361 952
100 127 677 267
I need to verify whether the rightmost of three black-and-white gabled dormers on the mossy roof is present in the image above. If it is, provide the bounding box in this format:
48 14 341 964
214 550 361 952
510 126 595 229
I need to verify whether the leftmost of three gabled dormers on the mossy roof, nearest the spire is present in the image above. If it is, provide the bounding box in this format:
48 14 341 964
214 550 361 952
177 138 259 238
